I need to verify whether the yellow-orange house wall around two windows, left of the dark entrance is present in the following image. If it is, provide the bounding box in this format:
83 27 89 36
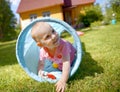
20 5 63 29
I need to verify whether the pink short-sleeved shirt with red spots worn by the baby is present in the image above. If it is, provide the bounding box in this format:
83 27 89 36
40 39 76 70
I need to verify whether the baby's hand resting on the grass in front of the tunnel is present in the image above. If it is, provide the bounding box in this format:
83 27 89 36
55 80 66 92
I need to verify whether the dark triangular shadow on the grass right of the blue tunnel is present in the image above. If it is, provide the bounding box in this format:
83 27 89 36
70 43 104 81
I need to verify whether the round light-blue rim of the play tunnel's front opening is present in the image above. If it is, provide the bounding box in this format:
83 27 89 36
16 17 82 83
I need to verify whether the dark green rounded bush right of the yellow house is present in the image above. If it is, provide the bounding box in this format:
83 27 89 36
78 5 103 27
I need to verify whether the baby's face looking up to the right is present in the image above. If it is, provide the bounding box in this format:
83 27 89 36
41 28 60 48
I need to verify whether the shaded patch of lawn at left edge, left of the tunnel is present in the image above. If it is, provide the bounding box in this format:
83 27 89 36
0 41 17 66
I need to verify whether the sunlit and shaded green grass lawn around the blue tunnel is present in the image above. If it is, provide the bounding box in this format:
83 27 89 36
0 23 120 92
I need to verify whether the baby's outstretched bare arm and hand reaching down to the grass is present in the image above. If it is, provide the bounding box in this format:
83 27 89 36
55 55 70 92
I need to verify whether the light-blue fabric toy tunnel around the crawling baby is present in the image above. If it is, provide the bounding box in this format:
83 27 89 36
16 17 82 83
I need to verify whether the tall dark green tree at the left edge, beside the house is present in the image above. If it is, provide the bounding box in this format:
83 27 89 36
0 0 16 40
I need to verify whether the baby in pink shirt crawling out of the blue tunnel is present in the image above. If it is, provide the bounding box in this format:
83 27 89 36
31 22 76 92
